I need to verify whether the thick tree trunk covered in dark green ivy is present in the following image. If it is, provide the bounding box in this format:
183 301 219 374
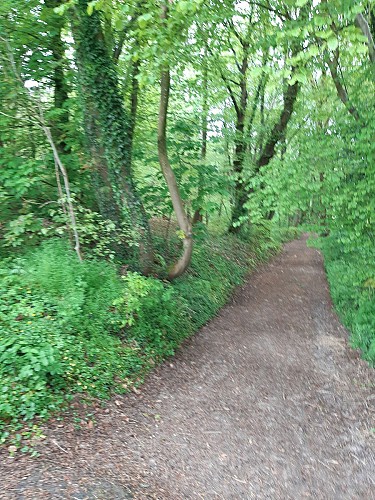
72 0 152 271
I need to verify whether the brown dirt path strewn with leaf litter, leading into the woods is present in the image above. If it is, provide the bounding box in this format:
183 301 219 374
0 240 375 500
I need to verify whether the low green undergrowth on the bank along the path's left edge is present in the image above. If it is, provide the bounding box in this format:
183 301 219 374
0 226 280 451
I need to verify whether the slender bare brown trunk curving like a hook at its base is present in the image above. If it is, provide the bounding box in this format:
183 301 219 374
158 69 193 280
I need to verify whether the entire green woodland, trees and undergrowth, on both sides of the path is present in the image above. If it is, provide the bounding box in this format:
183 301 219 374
0 0 375 452
